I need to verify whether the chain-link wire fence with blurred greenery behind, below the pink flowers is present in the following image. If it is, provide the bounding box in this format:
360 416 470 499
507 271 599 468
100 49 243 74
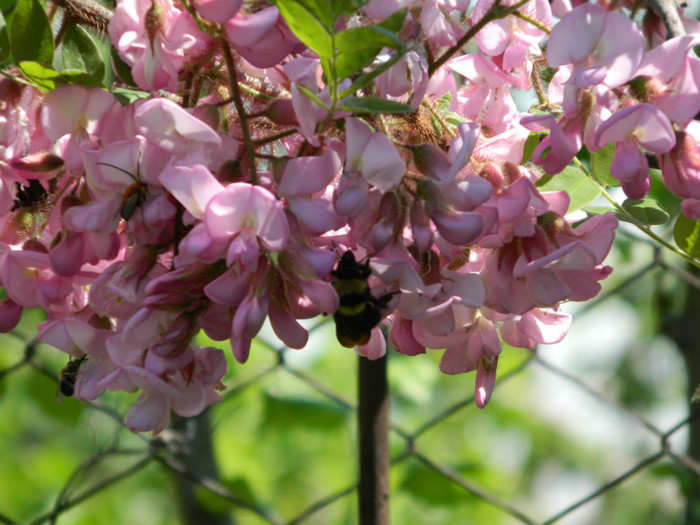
0 232 700 525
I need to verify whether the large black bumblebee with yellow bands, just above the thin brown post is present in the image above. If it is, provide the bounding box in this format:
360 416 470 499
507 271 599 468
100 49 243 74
331 250 393 348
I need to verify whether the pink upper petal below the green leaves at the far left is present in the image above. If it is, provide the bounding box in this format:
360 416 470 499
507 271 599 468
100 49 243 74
41 84 117 140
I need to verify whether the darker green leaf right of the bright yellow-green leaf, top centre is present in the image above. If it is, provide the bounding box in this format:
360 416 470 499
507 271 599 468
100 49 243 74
335 26 401 80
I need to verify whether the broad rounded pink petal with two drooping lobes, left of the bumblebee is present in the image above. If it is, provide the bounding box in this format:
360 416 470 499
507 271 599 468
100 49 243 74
204 182 289 250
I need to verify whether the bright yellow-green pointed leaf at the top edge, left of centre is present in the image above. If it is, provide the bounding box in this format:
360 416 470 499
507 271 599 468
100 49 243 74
277 0 335 58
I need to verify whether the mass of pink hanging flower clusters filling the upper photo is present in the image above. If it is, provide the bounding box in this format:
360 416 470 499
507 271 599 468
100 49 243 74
0 0 700 432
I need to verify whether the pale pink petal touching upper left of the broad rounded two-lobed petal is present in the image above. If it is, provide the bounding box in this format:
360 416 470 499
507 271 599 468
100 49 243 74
160 164 224 219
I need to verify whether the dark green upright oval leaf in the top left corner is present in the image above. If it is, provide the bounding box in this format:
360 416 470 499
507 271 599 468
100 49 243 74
10 0 54 65
